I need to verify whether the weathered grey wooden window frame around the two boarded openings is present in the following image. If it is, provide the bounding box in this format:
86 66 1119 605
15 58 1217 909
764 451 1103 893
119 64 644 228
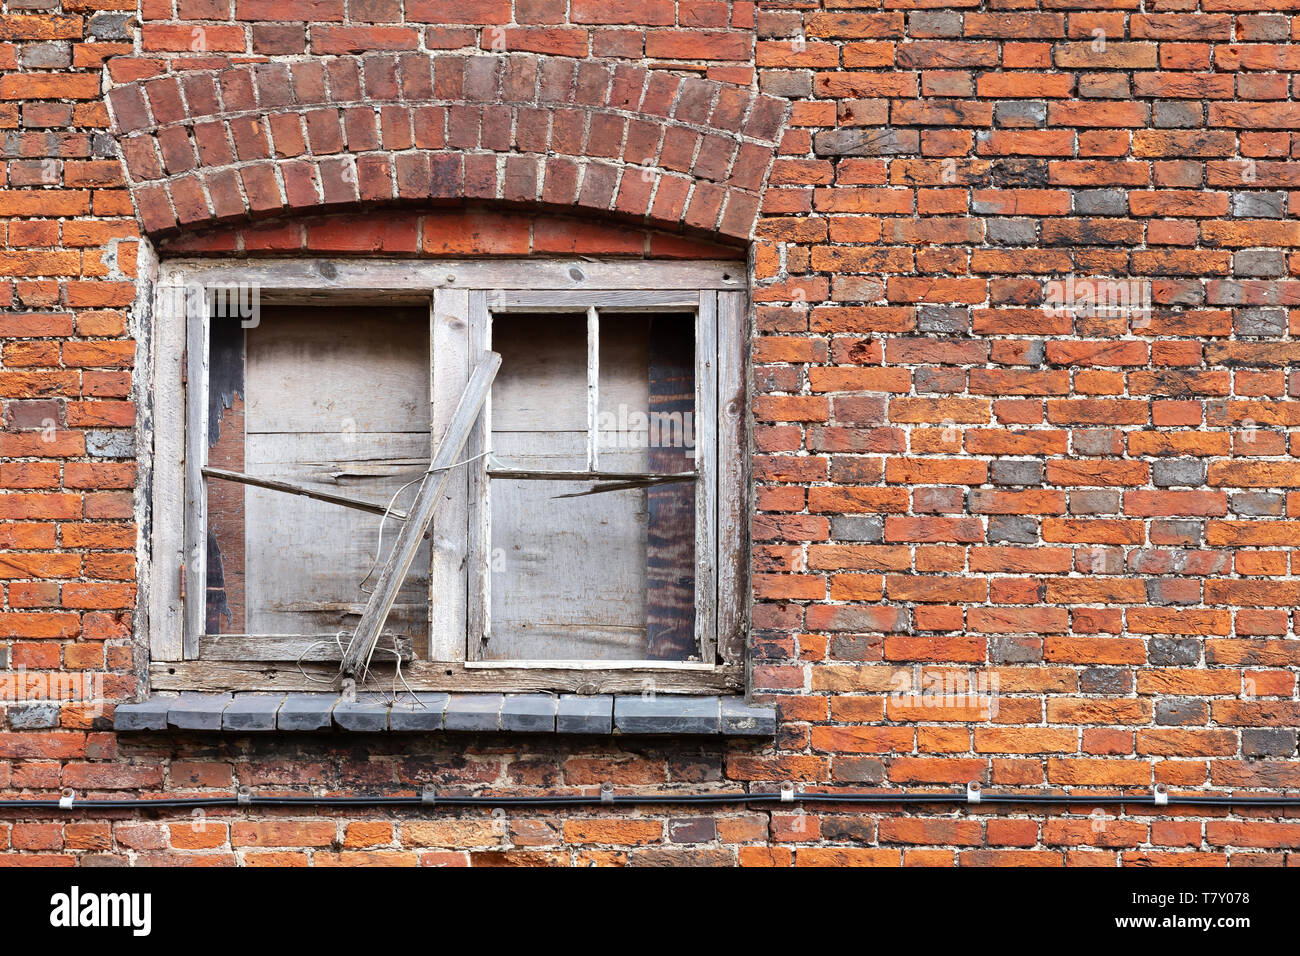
140 259 750 693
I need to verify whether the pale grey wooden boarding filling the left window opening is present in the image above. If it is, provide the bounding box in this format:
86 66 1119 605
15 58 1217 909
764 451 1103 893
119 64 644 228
240 307 432 654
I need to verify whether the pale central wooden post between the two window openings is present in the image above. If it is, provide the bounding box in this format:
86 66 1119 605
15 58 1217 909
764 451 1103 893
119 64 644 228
429 289 477 661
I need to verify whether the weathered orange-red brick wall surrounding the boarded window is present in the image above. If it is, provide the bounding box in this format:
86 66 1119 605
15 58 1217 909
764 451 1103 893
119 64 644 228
0 0 1300 866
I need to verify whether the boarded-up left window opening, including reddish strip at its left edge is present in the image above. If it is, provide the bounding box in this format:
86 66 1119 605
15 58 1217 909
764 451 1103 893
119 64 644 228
205 307 430 658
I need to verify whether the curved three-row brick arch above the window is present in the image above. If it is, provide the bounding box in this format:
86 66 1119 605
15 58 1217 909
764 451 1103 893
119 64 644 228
108 53 788 239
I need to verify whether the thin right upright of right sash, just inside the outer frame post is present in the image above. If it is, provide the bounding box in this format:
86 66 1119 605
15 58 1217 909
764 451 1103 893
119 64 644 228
696 291 718 663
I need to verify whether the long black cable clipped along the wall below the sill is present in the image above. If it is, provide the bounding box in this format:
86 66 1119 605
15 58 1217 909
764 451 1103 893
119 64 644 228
0 790 1300 812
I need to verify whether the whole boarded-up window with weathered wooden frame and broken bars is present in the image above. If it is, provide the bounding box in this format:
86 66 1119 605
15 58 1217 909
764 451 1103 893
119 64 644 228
147 260 748 692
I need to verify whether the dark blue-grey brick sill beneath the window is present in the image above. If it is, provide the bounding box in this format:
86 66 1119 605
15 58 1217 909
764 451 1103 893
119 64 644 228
113 693 776 737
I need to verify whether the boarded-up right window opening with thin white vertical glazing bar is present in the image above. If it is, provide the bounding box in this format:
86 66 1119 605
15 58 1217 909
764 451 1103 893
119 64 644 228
484 311 698 661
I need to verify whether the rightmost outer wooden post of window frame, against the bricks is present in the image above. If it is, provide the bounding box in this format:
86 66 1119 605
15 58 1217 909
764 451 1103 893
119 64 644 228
715 293 750 663
